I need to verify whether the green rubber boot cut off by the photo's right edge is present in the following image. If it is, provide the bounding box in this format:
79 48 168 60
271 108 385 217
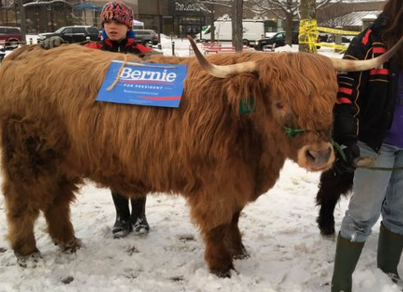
377 222 403 283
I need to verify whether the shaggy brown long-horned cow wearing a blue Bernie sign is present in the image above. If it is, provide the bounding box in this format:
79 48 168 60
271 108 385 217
0 37 400 276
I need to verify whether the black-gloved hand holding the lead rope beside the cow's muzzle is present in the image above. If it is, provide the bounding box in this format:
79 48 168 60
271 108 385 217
333 143 360 174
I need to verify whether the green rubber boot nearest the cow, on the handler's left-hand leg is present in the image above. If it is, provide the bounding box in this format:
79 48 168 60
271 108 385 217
331 234 364 292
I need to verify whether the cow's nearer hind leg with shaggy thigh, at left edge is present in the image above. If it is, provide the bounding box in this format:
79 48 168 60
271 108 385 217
1 116 74 264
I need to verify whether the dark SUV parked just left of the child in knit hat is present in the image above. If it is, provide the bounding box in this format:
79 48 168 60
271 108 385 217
38 25 99 43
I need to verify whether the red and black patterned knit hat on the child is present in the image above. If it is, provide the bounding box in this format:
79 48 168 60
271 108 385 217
101 1 134 28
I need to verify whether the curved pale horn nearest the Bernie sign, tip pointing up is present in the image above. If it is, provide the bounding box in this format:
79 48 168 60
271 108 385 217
188 36 257 78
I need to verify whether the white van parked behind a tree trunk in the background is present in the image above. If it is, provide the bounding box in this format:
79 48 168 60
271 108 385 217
196 19 268 46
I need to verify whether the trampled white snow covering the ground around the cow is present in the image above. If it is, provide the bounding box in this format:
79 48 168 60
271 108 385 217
0 33 401 292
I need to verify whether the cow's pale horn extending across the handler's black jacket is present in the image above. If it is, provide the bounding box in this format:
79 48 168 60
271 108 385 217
330 37 403 72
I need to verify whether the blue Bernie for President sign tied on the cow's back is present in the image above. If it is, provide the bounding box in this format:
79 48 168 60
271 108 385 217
96 60 187 108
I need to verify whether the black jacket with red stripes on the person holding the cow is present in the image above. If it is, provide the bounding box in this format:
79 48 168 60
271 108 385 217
334 15 399 152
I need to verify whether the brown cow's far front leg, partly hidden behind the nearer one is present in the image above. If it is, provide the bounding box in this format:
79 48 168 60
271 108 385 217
224 211 249 259
